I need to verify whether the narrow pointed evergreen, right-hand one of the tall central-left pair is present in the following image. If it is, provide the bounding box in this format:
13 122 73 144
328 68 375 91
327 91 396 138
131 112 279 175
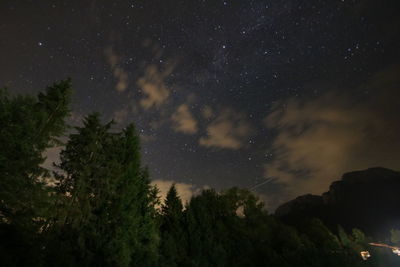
109 124 159 266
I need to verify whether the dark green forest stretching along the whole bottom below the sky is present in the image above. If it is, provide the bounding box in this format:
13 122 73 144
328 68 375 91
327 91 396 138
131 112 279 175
0 80 400 267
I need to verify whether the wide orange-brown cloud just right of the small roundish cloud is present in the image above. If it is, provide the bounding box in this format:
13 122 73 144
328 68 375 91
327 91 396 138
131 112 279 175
199 109 252 149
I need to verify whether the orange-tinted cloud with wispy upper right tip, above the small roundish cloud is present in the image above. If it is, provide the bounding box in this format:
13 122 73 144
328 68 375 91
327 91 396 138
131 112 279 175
137 63 175 109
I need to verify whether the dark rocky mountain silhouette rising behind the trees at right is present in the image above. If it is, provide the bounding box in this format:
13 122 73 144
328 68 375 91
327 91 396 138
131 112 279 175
275 167 400 239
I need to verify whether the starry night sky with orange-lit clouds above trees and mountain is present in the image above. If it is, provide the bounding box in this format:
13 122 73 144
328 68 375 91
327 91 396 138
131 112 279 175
0 0 400 209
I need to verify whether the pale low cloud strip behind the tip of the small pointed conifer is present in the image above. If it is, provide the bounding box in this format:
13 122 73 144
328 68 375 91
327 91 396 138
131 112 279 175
151 180 201 204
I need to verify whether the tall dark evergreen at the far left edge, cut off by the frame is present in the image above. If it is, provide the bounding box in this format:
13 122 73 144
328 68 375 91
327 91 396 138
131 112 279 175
0 80 71 265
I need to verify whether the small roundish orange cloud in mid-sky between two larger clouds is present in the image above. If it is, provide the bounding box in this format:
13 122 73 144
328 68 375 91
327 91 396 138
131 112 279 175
171 104 198 134
